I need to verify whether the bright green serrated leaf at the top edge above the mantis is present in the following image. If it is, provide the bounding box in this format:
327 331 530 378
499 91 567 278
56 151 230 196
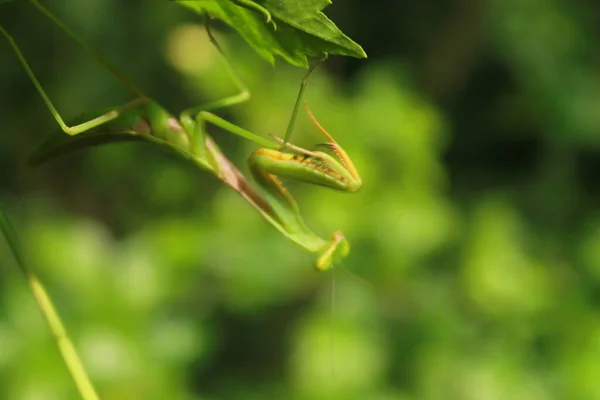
178 0 367 68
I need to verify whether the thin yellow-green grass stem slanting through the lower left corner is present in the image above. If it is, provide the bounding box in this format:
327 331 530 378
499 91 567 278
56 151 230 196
0 209 100 400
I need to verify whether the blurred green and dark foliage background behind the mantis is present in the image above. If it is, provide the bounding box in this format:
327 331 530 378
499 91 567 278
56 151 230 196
0 0 600 400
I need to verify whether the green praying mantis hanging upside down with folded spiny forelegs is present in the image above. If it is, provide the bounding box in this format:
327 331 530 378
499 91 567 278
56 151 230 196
0 0 362 271
